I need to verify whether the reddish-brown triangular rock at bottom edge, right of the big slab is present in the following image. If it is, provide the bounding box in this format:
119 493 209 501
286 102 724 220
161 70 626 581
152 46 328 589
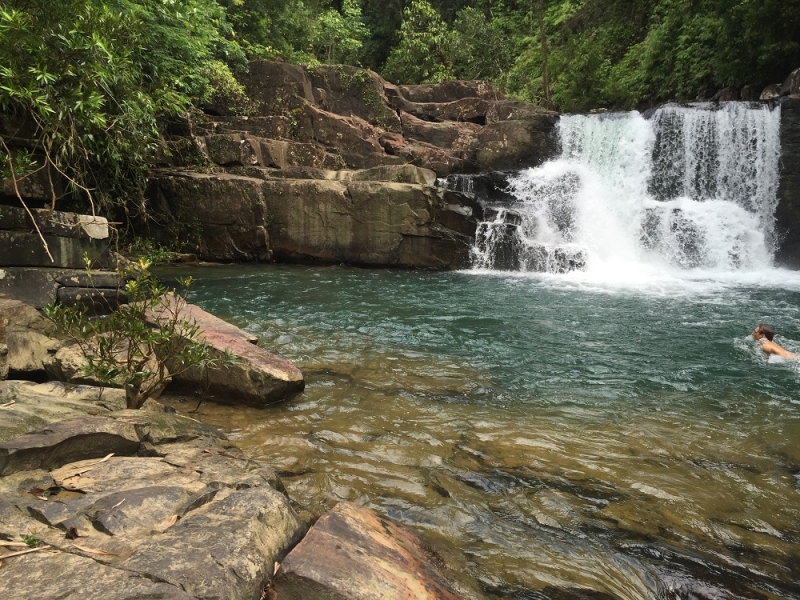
273 502 476 600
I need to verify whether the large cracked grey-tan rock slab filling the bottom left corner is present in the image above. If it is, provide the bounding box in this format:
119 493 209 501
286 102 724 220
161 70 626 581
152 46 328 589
0 398 305 600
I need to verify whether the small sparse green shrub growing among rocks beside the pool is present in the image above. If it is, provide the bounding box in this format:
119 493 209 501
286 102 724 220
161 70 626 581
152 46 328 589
44 260 235 409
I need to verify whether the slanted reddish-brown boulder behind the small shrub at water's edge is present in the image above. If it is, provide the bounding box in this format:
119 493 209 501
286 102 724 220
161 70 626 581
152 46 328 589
148 295 305 406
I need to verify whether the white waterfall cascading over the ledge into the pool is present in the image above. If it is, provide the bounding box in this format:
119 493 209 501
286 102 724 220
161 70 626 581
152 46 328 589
468 102 780 273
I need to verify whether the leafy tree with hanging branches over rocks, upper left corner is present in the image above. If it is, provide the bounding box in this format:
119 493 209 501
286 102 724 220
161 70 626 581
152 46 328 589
0 0 244 227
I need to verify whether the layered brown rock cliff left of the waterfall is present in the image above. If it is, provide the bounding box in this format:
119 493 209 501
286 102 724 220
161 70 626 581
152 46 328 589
149 61 557 269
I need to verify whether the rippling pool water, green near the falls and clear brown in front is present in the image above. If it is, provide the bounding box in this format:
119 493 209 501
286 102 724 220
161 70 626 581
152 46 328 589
158 267 800 600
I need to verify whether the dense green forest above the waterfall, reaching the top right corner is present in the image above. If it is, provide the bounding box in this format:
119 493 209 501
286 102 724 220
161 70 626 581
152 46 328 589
376 0 800 111
